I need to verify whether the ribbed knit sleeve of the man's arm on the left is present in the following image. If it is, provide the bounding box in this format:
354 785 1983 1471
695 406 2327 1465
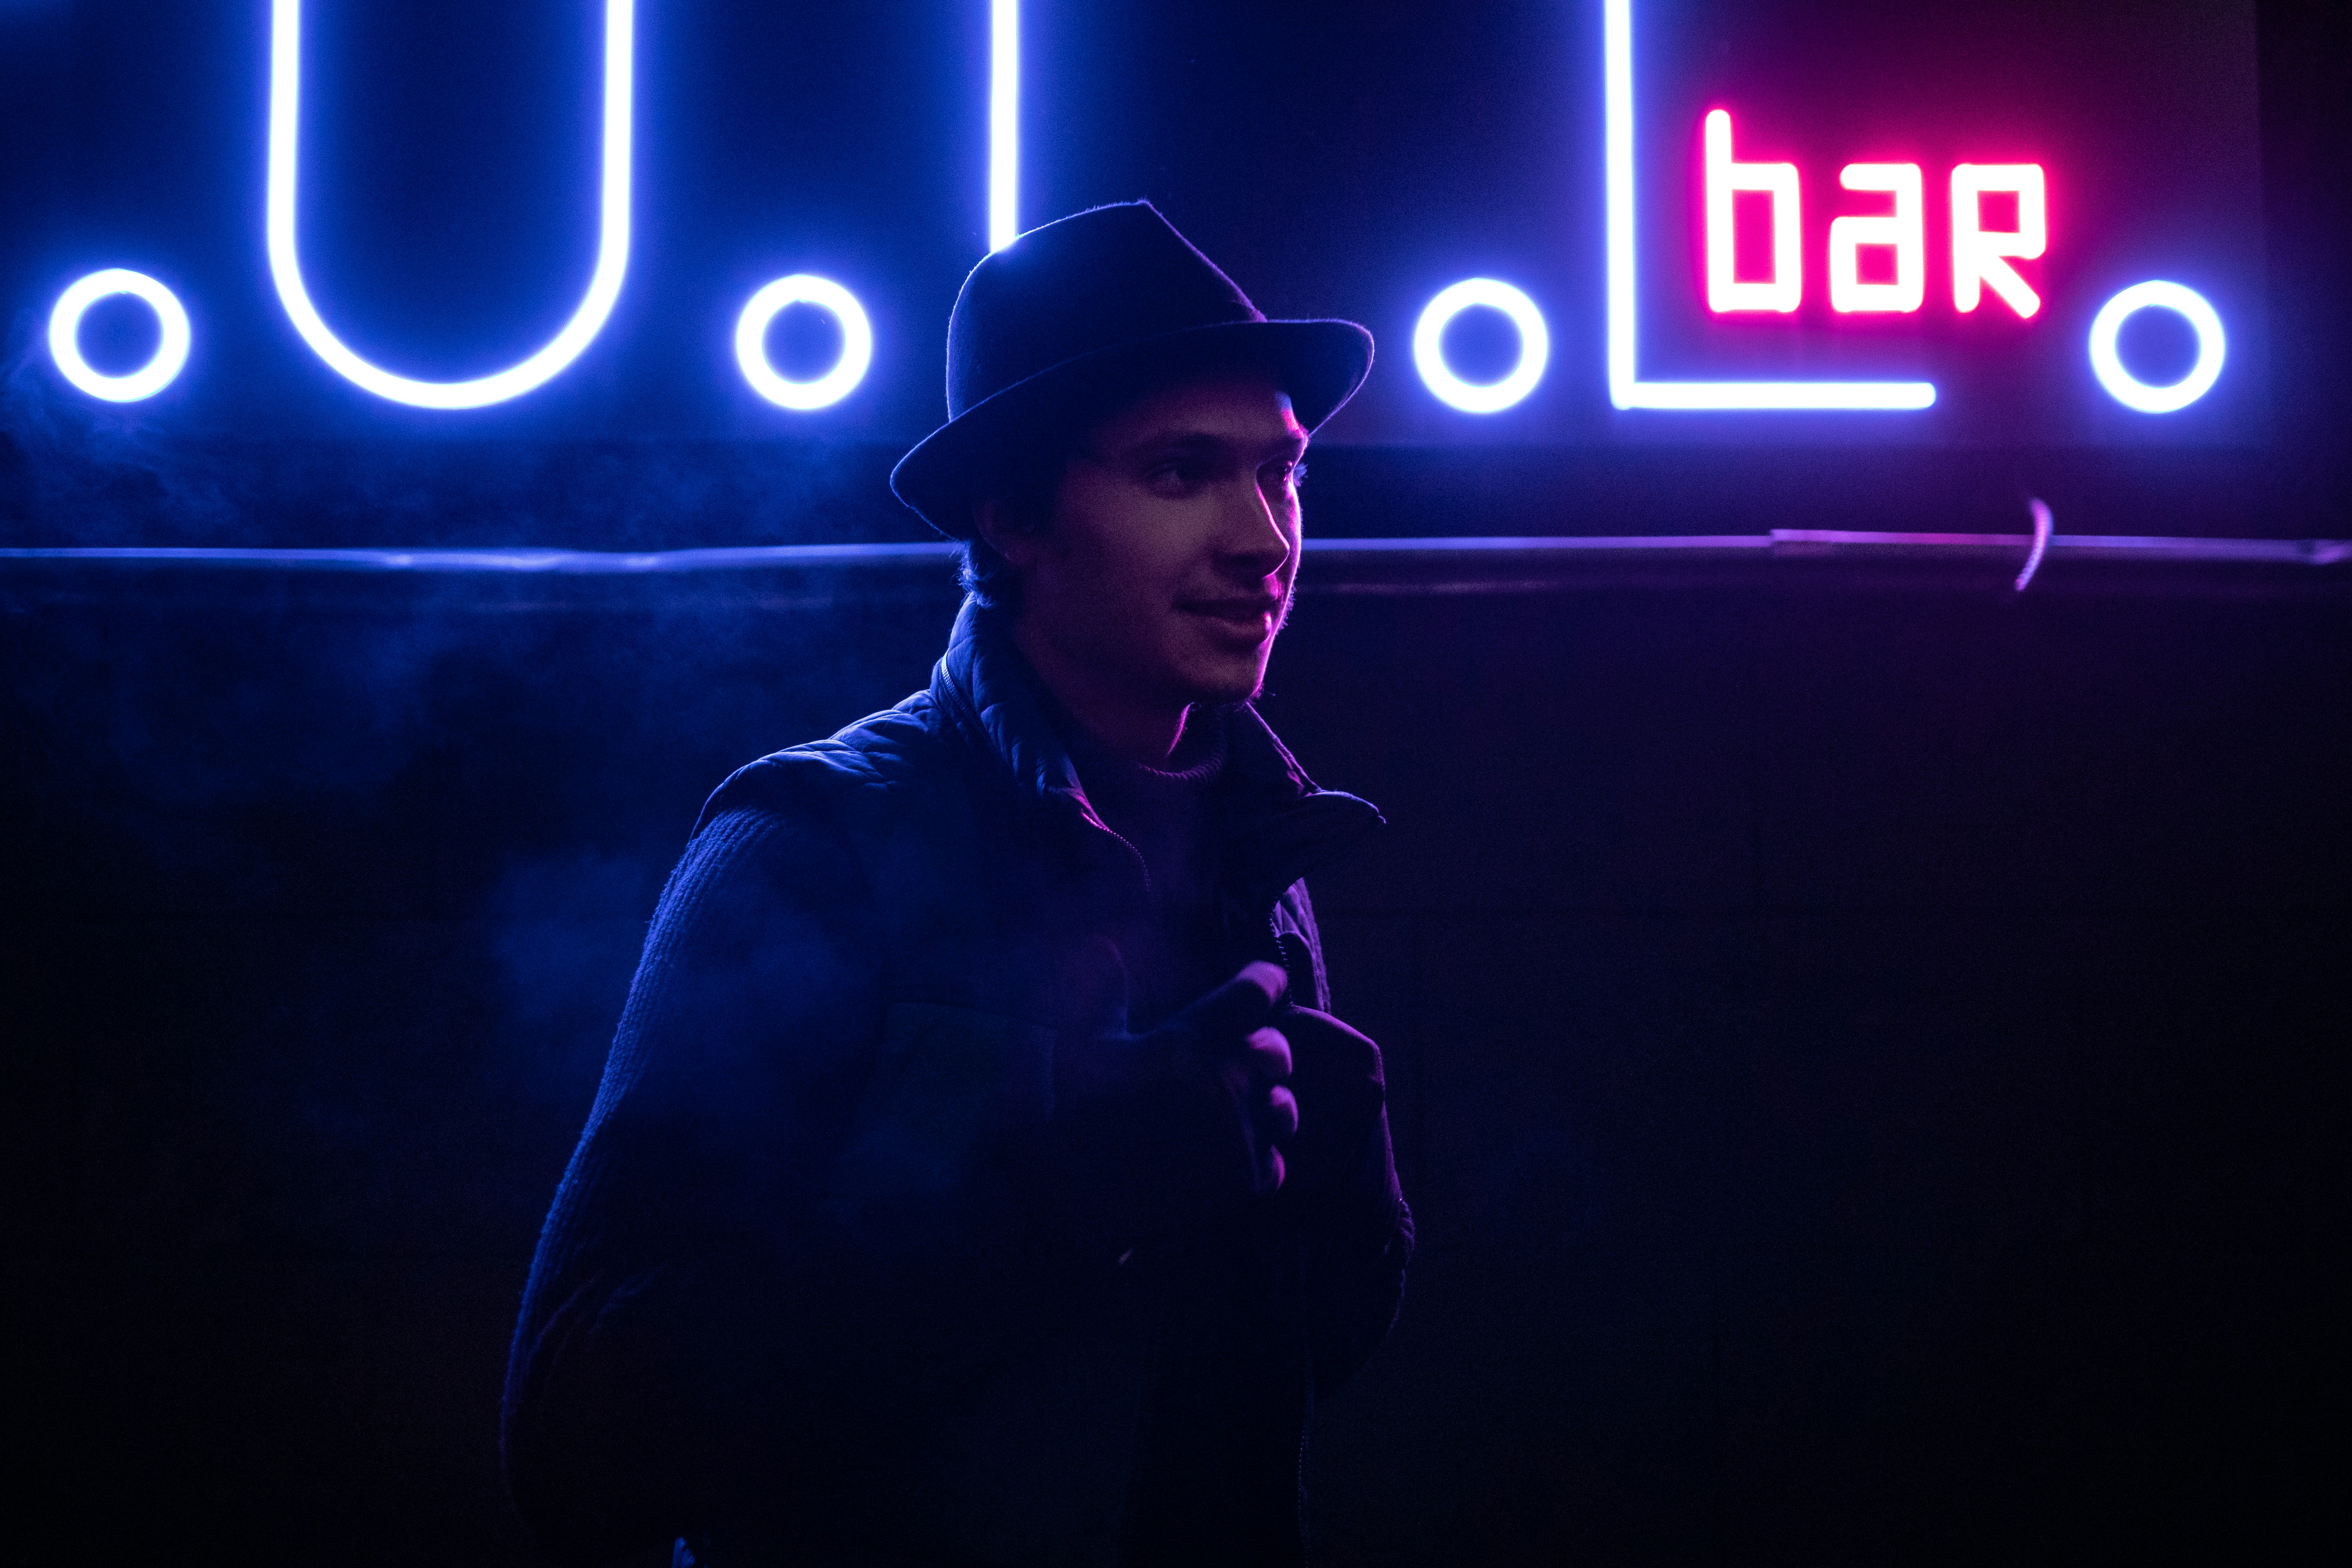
503 806 1077 1561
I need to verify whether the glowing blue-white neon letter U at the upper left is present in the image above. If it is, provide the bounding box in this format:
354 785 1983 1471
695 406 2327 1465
268 0 635 409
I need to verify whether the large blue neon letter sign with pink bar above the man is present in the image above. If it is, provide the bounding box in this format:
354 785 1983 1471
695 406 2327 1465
18 0 2263 444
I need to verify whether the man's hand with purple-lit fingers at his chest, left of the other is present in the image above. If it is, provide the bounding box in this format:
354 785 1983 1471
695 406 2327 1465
1051 943 1298 1241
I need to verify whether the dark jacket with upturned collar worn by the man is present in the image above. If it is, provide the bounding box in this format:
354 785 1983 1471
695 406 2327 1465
503 604 1411 1568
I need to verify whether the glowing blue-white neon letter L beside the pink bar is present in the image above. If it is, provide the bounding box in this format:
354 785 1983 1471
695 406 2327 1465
1602 0 1936 411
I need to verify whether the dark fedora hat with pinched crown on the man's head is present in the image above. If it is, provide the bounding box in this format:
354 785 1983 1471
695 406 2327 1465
889 202 1371 538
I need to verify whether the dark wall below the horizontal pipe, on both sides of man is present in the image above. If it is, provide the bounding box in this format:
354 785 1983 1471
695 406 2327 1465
0 560 2352 1563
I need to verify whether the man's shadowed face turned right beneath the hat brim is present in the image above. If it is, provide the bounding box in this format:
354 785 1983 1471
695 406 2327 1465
1006 371 1308 705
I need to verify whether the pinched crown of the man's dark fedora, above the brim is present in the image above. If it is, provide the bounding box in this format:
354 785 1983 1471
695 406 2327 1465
948 202 1265 419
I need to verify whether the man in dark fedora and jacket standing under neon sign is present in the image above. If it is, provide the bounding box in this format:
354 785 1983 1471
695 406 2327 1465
506 202 1411 1568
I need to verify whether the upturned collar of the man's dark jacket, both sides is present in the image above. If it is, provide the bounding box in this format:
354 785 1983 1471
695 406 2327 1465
931 599 1381 905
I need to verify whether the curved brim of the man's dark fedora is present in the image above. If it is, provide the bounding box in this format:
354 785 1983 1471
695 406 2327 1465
889 322 1371 538
